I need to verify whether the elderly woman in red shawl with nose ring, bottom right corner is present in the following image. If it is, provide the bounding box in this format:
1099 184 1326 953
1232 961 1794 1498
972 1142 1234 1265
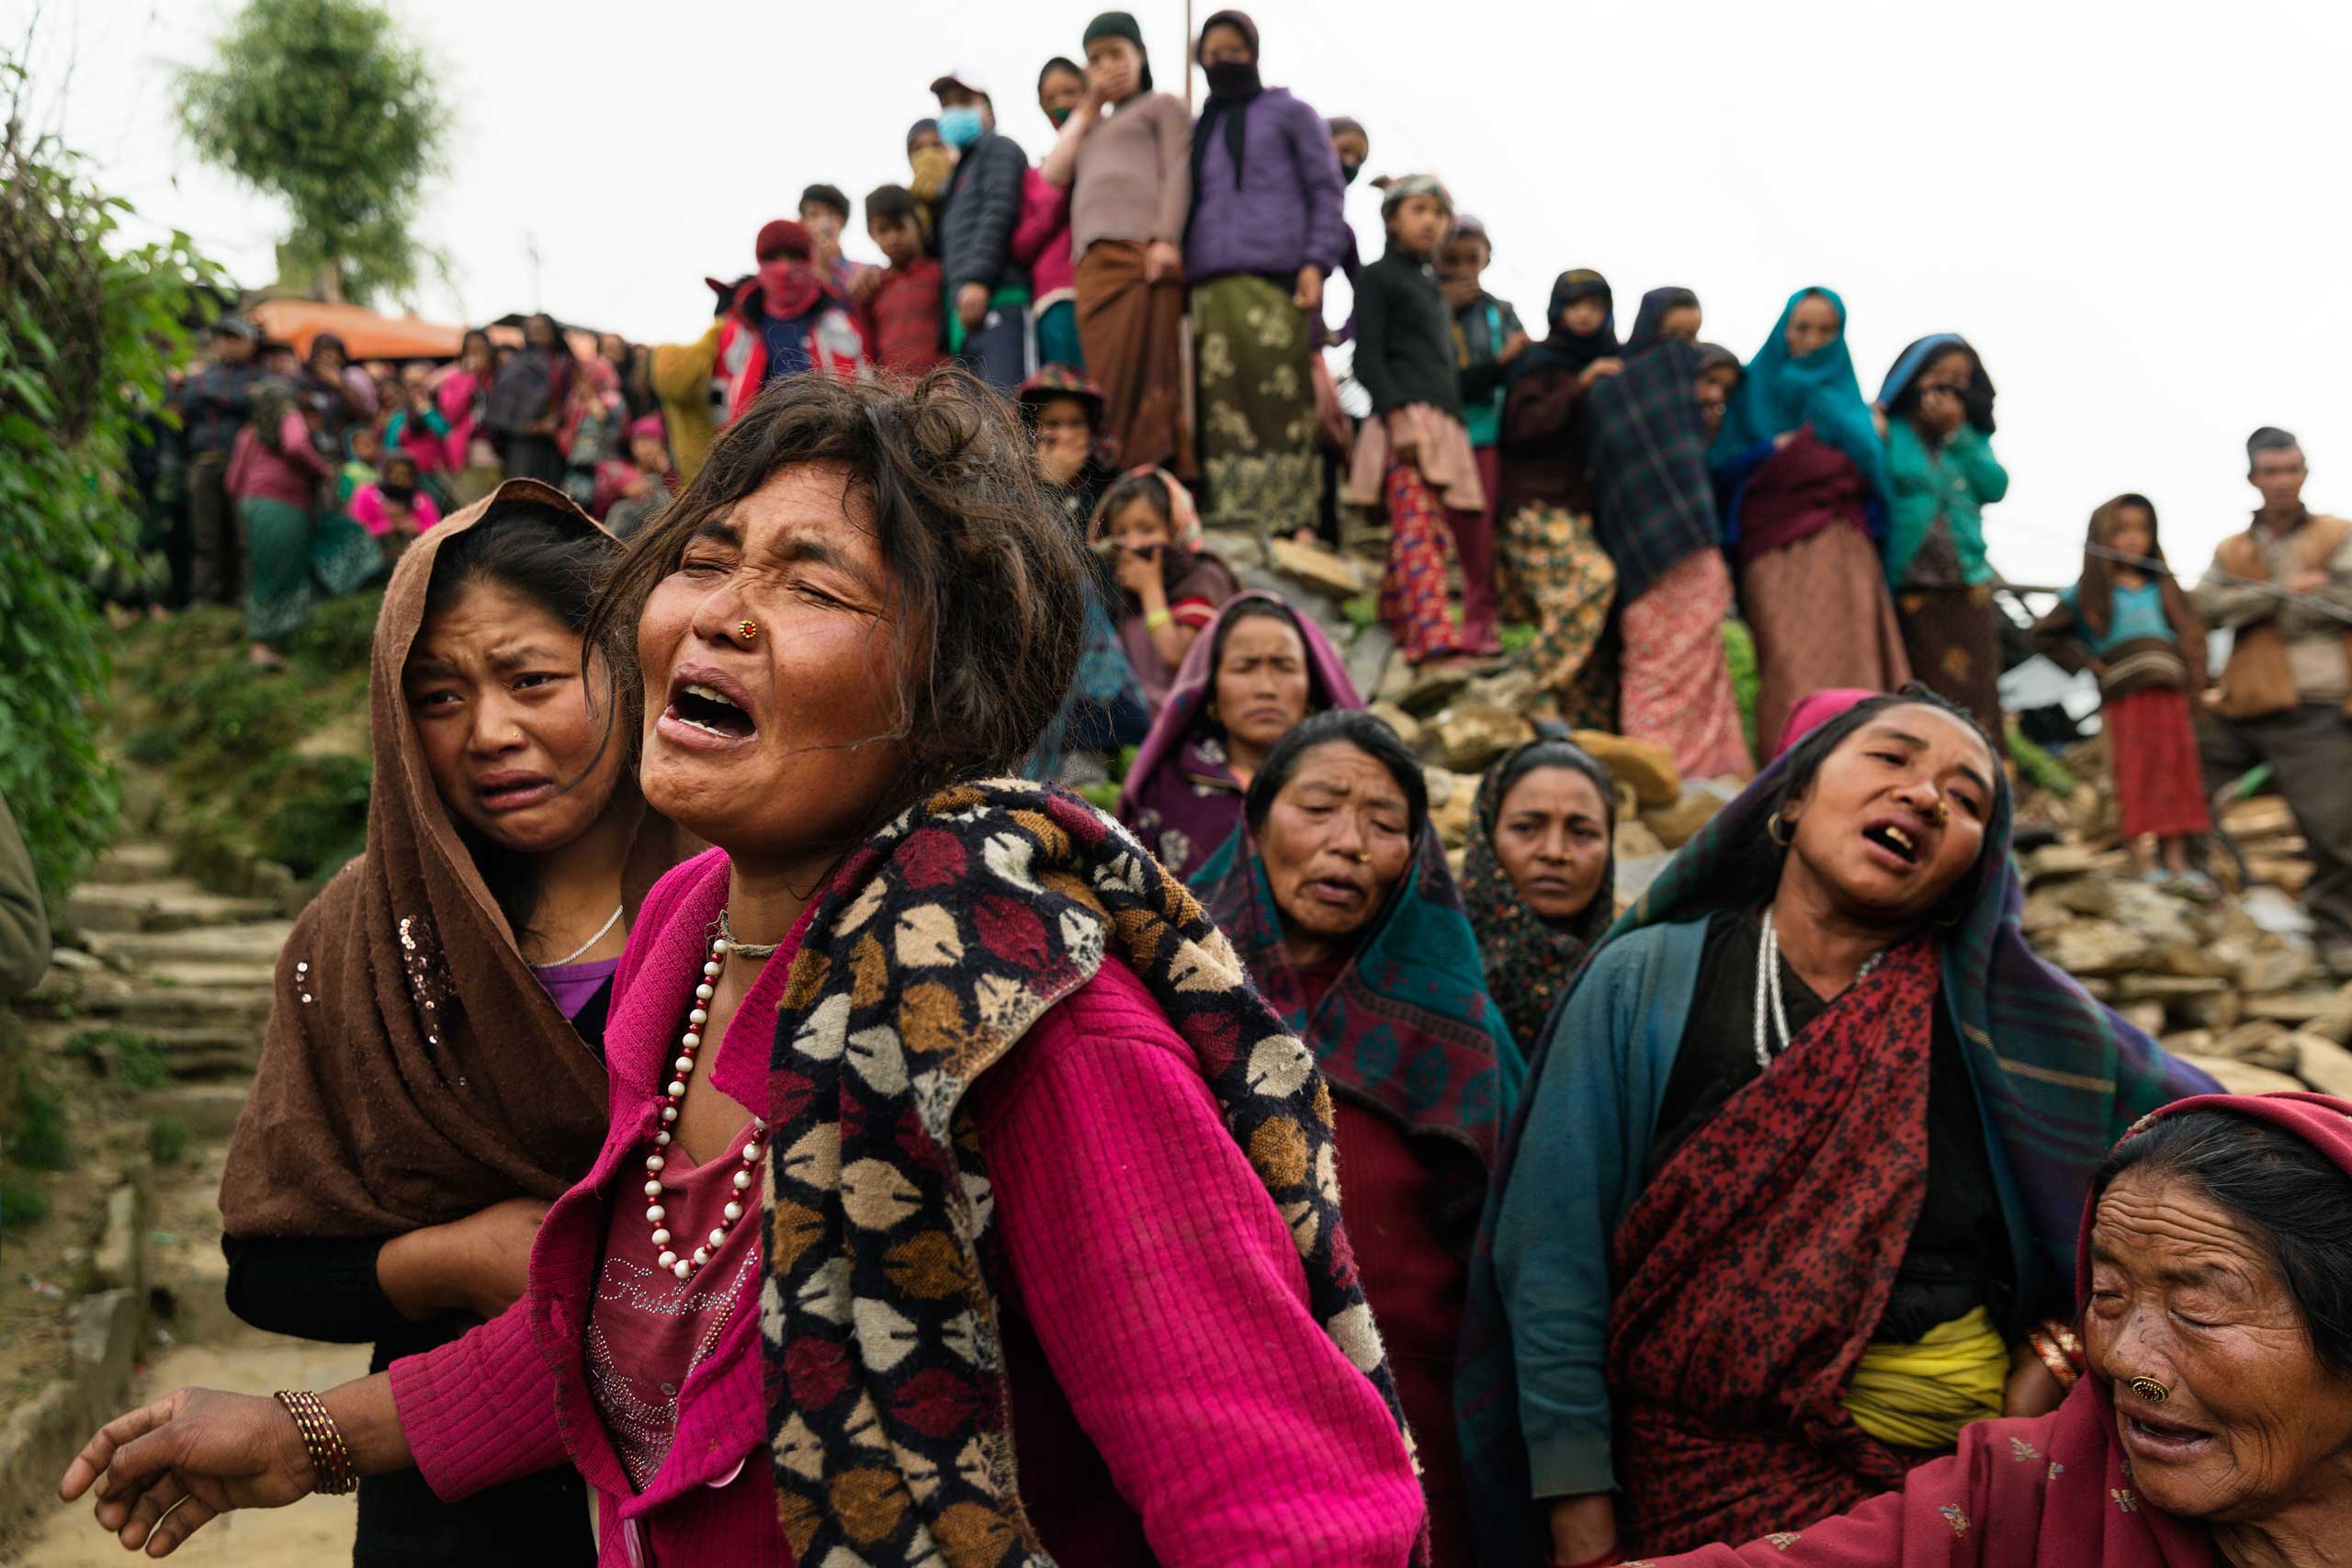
1646 1093 2352 1568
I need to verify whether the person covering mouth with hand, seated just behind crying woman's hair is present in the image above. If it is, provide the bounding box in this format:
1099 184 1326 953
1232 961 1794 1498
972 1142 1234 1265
1087 468 1242 715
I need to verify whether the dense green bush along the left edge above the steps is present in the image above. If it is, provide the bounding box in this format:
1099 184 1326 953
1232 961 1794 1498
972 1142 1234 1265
0 56 217 896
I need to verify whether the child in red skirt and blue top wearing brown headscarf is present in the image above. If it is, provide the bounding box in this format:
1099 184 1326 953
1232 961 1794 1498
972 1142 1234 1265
2032 493 2216 898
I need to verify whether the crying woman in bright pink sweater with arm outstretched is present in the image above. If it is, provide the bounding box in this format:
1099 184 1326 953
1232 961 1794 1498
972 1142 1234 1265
63 371 1425 1568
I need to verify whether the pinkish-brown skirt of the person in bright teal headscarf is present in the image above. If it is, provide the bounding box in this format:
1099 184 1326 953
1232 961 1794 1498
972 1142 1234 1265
1740 525 1910 761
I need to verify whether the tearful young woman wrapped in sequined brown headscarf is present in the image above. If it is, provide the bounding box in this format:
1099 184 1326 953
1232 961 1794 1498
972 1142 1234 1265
221 479 684 1565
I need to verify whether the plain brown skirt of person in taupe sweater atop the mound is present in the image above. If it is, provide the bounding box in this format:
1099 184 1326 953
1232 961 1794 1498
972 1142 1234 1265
1077 240 1200 479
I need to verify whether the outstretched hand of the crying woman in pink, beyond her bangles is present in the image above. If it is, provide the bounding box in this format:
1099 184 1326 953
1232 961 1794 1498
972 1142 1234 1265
56 1389 318 1556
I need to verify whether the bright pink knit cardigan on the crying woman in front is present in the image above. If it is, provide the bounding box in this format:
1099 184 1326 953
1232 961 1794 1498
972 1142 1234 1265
390 851 1423 1568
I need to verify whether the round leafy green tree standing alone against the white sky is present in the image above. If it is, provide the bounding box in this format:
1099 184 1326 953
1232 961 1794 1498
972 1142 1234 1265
176 0 447 303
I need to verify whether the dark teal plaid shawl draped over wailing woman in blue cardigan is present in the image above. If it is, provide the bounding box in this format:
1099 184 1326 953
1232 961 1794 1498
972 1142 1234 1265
1456 719 2213 1550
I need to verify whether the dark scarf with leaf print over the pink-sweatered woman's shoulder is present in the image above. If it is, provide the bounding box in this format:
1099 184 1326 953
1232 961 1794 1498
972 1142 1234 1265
760 778 1402 1568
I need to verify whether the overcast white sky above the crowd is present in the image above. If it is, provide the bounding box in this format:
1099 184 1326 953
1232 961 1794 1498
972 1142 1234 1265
18 0 2352 581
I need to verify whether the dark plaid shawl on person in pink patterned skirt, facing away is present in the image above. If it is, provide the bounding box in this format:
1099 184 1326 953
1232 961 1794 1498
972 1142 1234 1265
1585 339 1724 604
